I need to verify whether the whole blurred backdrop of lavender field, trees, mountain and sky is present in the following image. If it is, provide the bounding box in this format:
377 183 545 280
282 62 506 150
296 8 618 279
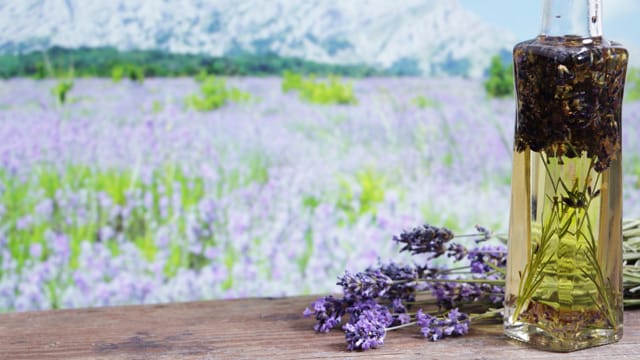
0 0 640 312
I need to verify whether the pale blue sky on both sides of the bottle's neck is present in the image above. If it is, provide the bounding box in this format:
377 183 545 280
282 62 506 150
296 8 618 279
459 0 640 64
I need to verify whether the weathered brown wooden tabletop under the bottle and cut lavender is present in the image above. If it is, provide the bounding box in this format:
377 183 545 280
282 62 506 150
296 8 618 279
0 297 640 360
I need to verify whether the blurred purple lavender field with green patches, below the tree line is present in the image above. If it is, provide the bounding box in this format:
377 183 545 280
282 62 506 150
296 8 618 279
0 78 640 312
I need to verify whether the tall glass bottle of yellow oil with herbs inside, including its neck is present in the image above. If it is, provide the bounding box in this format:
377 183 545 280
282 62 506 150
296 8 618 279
504 0 628 351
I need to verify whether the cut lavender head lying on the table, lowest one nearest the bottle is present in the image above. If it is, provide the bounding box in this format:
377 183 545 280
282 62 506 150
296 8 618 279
416 308 471 341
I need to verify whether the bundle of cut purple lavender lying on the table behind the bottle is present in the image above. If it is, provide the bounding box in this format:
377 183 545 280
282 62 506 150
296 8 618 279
304 220 640 350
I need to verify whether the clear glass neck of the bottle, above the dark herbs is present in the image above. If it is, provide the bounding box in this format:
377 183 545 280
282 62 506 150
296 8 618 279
540 0 602 38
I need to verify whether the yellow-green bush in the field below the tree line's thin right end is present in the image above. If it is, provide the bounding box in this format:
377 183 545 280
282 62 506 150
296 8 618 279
282 71 358 105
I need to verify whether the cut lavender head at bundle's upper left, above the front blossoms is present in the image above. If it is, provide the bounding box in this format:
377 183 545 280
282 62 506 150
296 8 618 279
337 270 393 300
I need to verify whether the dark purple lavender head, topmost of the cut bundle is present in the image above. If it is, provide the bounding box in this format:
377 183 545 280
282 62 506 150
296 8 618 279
393 224 454 259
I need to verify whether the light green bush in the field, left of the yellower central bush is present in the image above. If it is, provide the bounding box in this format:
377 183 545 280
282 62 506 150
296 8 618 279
185 75 251 111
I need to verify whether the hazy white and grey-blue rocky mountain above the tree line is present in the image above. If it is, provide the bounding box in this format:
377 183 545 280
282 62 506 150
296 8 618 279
0 0 514 76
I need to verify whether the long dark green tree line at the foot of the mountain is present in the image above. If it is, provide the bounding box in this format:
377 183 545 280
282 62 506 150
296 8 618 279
0 47 388 78
